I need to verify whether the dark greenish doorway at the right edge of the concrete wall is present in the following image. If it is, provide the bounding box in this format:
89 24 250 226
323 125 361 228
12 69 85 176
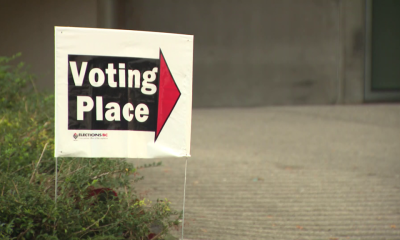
366 0 400 101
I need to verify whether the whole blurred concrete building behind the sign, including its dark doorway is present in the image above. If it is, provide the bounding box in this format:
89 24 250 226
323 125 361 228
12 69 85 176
0 0 400 107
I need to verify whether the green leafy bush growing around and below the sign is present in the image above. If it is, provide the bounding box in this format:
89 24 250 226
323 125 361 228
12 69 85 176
0 55 181 240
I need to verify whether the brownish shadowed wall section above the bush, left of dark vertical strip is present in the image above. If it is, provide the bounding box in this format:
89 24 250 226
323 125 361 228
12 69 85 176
0 0 97 91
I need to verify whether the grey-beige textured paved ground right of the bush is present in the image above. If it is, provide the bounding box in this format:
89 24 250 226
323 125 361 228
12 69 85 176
131 104 400 240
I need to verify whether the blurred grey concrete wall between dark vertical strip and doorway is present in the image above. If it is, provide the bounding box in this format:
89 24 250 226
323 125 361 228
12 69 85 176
127 0 364 107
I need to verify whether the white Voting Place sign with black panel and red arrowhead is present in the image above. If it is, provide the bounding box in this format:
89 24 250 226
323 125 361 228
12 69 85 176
55 27 193 158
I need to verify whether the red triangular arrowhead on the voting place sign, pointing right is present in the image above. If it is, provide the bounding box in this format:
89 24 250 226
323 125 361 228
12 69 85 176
154 49 181 141
